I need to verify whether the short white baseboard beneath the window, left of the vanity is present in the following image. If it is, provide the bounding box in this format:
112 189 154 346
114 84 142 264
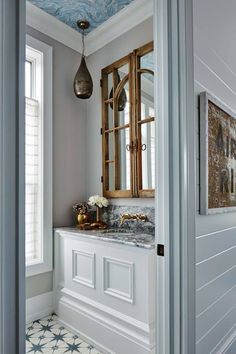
26 291 54 324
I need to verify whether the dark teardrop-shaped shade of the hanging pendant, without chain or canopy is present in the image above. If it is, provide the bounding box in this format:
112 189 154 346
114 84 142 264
74 56 93 99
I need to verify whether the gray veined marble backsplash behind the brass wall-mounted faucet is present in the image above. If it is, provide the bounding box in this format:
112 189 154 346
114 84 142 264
102 205 155 235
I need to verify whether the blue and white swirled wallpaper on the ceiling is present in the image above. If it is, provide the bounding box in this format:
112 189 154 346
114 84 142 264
29 0 133 33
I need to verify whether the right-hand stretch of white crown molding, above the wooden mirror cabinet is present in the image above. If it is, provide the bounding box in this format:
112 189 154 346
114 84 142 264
86 0 153 55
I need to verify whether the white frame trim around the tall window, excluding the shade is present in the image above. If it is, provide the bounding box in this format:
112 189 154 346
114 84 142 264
26 35 53 277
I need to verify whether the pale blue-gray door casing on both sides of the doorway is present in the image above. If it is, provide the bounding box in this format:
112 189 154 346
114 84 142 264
0 0 195 354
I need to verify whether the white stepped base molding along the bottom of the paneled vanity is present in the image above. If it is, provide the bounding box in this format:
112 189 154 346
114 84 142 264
56 288 155 354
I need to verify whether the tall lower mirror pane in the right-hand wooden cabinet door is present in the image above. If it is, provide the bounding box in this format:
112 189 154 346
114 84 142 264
141 121 155 189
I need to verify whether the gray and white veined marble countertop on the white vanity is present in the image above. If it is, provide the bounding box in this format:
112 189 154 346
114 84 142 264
55 227 155 249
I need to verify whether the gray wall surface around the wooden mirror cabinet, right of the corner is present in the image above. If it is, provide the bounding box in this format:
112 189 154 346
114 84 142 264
86 18 153 205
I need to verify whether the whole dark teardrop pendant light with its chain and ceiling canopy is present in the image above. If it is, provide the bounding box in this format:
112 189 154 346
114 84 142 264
74 20 93 99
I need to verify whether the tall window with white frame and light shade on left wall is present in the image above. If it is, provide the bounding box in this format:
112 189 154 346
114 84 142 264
25 36 52 275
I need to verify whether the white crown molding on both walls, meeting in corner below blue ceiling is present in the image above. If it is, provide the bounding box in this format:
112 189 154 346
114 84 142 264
26 0 153 55
